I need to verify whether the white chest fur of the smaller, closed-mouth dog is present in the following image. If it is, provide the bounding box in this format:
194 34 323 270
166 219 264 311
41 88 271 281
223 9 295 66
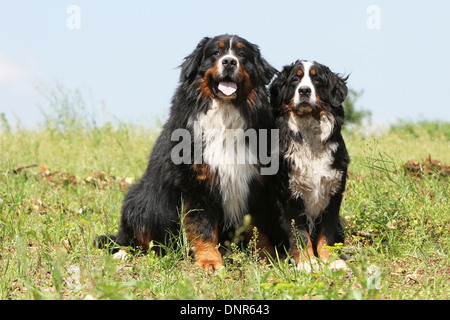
284 114 342 229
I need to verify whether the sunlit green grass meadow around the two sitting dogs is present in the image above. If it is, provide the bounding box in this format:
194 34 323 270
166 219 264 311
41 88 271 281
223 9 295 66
0 101 450 300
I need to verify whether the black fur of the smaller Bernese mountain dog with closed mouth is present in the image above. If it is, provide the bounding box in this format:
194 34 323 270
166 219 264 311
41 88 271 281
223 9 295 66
270 61 350 262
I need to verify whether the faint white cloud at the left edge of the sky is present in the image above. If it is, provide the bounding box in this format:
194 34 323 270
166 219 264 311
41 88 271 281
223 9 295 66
0 52 39 93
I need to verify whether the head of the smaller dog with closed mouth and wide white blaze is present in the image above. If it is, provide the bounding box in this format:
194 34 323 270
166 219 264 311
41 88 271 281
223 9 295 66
270 60 348 117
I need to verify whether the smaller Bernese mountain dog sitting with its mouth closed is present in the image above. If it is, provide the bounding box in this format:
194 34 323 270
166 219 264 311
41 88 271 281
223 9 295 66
270 60 350 270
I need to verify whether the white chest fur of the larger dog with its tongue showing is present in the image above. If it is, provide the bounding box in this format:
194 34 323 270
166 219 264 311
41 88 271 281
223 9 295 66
195 100 259 225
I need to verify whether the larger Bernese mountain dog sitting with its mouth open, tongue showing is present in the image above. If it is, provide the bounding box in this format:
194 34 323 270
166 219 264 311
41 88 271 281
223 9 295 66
96 35 278 270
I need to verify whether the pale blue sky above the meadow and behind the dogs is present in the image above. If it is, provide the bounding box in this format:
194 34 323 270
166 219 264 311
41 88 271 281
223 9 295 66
0 0 450 126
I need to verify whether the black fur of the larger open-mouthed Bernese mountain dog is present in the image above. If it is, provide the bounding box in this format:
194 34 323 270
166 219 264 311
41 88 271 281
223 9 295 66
97 35 276 266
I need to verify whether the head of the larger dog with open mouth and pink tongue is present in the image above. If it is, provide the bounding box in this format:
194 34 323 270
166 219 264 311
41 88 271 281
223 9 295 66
180 35 276 100
